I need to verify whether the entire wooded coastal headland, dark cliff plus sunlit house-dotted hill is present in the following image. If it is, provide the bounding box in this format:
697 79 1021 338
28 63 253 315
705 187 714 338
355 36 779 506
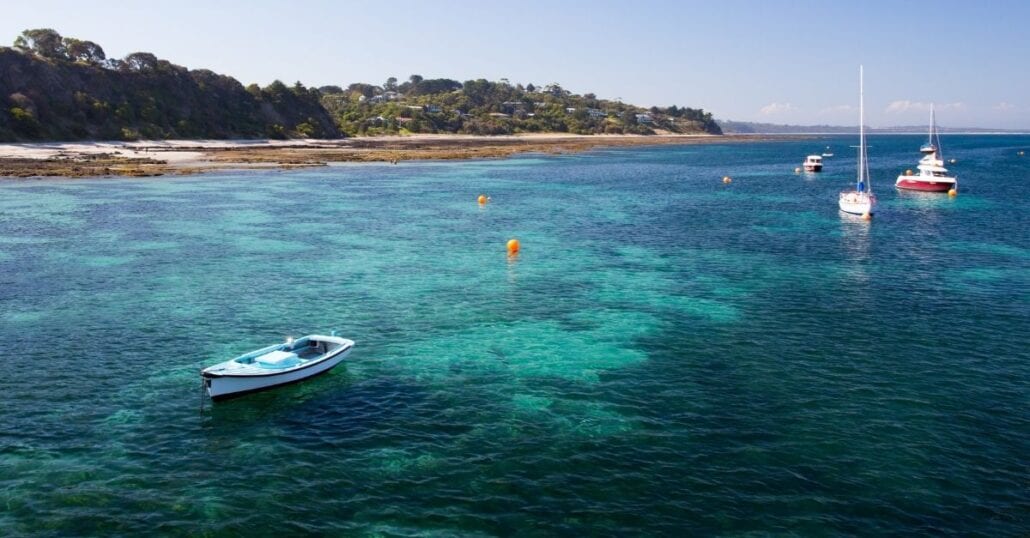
0 29 721 142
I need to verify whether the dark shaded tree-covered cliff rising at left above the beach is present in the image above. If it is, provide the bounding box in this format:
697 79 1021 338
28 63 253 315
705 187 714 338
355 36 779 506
0 29 342 141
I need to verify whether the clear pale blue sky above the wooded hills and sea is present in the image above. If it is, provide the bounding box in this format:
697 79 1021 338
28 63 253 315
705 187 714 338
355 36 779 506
0 0 1030 129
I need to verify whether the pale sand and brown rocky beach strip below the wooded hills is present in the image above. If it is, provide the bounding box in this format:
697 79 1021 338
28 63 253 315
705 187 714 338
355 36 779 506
0 133 782 179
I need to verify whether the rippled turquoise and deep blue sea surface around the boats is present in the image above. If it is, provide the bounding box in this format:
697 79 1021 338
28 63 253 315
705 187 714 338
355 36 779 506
0 136 1030 537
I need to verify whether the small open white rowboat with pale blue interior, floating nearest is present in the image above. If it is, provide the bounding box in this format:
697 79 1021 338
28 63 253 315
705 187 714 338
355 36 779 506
200 334 354 400
